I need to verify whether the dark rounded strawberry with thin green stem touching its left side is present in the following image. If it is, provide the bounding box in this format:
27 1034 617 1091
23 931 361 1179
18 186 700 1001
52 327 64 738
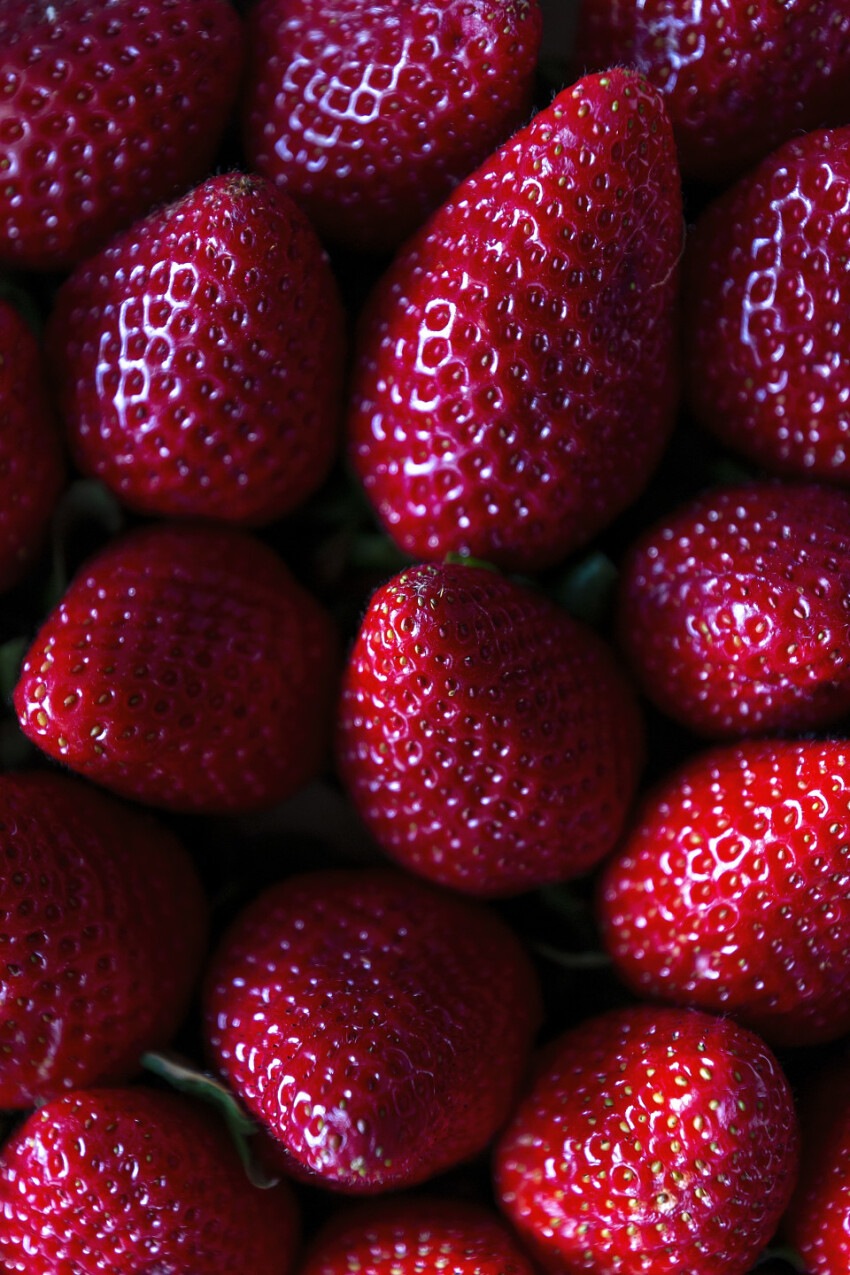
206 870 539 1193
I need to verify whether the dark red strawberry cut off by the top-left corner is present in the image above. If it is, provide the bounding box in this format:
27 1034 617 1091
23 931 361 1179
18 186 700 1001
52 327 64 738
0 0 242 270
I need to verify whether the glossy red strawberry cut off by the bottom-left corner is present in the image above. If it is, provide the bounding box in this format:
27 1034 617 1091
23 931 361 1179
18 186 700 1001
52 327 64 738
0 1089 297 1275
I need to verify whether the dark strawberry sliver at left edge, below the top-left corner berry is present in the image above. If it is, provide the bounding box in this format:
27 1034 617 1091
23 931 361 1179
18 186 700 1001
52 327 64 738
0 298 65 590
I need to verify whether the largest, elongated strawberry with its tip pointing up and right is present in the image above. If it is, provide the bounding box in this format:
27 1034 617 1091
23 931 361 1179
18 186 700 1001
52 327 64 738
350 71 682 570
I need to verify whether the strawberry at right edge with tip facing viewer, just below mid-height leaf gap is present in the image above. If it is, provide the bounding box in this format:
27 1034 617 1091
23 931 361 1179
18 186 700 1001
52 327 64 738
619 483 850 737
